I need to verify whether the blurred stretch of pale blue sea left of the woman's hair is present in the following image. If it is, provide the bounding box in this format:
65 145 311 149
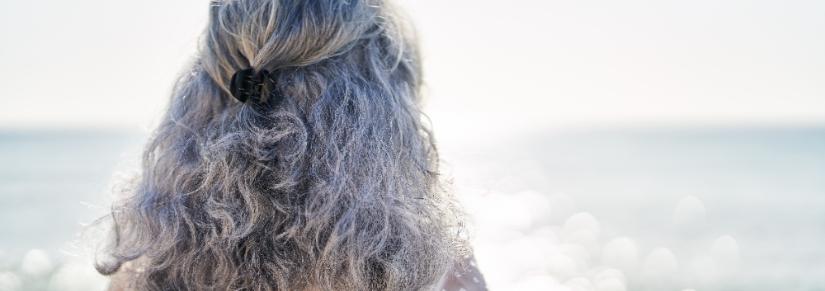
0 130 143 291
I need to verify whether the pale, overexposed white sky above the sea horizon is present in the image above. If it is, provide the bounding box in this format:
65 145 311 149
0 0 825 128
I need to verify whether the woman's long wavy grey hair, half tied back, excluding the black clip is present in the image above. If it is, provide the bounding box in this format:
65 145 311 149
98 0 461 290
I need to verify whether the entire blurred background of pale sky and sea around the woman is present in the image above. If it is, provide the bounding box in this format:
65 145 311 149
0 0 825 291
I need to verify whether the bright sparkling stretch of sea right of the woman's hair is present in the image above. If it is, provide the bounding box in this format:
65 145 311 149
440 127 825 290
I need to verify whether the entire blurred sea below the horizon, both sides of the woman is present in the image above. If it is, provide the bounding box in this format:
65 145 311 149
0 127 825 291
